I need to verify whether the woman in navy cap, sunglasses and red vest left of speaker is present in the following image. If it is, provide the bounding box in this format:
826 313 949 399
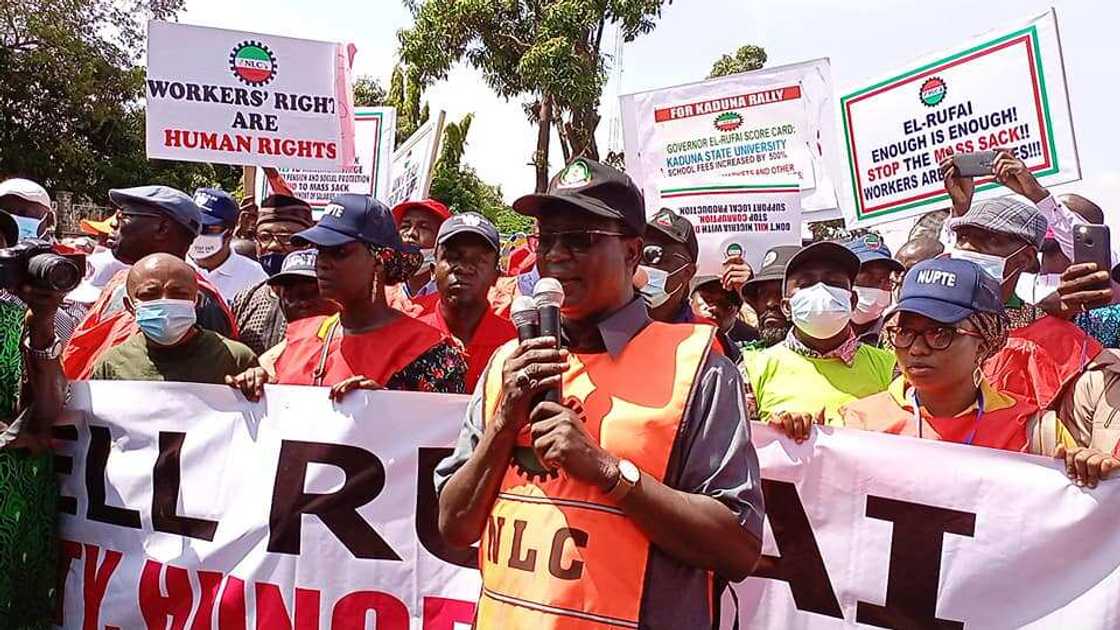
228 194 467 400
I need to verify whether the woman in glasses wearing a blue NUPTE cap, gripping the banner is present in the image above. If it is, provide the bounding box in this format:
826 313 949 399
840 258 1120 485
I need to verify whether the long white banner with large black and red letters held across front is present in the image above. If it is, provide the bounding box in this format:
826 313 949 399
56 382 1120 630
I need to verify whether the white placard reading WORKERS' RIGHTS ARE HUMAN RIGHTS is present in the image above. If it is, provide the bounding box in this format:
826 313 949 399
144 21 354 170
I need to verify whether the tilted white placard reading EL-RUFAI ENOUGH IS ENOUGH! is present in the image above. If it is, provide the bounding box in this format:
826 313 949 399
840 9 1081 225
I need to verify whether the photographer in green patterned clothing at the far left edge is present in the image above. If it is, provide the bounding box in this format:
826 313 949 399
0 207 70 628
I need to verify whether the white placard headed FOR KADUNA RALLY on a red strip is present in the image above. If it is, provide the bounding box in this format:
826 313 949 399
620 59 838 215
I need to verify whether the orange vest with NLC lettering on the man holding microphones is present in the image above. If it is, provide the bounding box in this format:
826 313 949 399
475 322 715 630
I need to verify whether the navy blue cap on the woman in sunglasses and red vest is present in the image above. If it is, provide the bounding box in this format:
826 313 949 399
291 193 417 252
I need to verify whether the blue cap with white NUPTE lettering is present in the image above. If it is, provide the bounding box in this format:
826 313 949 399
892 257 1004 324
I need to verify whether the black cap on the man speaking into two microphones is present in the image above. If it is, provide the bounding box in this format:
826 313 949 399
513 158 645 237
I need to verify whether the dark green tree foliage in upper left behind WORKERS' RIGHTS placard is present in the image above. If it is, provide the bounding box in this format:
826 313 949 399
0 0 240 202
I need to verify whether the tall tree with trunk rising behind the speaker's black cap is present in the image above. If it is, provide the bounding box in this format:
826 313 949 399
400 0 672 191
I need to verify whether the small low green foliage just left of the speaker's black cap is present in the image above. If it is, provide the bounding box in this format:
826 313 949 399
430 114 532 234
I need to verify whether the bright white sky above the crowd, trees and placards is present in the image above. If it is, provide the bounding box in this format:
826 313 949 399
179 0 1120 227
